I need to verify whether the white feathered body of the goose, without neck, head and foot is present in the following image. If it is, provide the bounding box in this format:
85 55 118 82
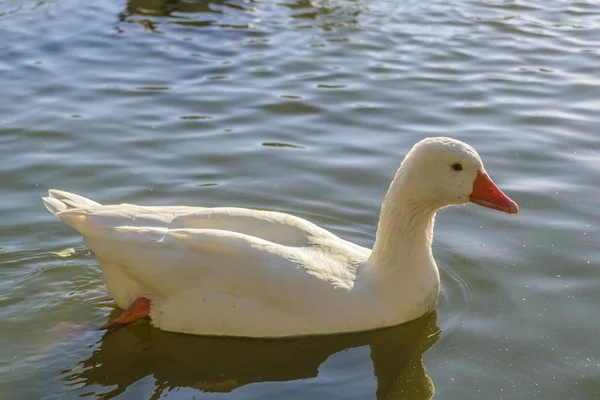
39 190 439 337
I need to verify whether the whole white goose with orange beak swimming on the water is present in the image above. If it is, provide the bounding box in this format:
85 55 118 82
43 138 518 337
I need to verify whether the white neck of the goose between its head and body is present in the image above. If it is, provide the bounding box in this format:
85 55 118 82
369 174 439 272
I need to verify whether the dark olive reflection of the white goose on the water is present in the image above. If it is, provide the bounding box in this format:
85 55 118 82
62 310 440 400
